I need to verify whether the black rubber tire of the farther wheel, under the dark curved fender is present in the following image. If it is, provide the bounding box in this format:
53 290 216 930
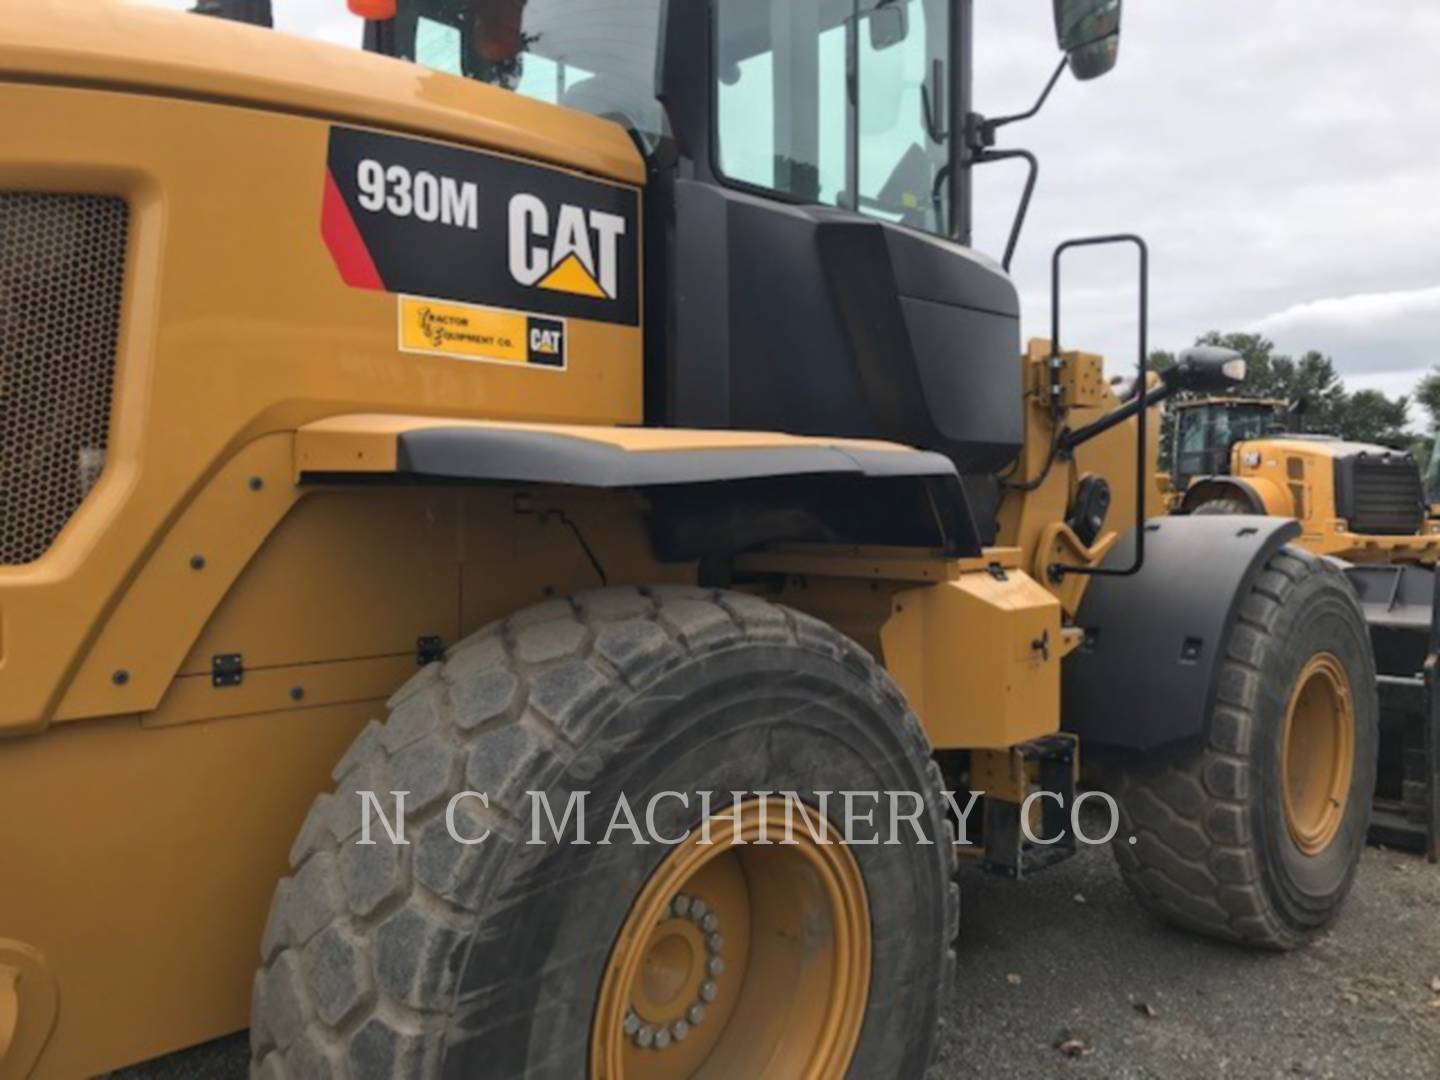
1112 547 1380 949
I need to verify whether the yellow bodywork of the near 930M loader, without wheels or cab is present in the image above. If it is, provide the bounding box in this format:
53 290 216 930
0 3 1159 1080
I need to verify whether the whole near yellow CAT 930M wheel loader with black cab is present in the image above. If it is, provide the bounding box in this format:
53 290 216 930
0 0 1377 1080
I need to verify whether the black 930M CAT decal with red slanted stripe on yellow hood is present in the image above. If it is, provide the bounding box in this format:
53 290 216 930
321 127 639 325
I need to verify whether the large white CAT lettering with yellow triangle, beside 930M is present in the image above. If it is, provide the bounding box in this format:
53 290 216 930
510 194 625 300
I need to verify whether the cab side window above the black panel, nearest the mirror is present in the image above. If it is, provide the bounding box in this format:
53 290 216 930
716 0 950 233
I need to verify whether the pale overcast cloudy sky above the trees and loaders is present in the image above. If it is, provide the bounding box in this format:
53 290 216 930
140 0 1440 420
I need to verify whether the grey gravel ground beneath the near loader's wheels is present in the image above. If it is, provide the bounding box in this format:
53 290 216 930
111 848 1440 1080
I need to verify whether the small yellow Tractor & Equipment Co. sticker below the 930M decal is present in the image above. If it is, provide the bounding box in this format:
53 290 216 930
400 297 564 370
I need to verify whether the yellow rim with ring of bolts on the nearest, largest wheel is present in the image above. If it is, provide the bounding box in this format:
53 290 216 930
590 798 870 1080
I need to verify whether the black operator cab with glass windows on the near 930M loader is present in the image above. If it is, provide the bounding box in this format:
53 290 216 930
350 0 1120 533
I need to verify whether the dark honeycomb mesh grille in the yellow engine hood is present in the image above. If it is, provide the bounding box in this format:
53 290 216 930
0 192 130 566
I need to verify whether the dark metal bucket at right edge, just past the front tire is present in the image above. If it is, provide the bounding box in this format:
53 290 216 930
1345 566 1440 863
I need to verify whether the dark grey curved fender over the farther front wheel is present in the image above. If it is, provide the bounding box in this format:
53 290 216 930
1061 516 1300 750
